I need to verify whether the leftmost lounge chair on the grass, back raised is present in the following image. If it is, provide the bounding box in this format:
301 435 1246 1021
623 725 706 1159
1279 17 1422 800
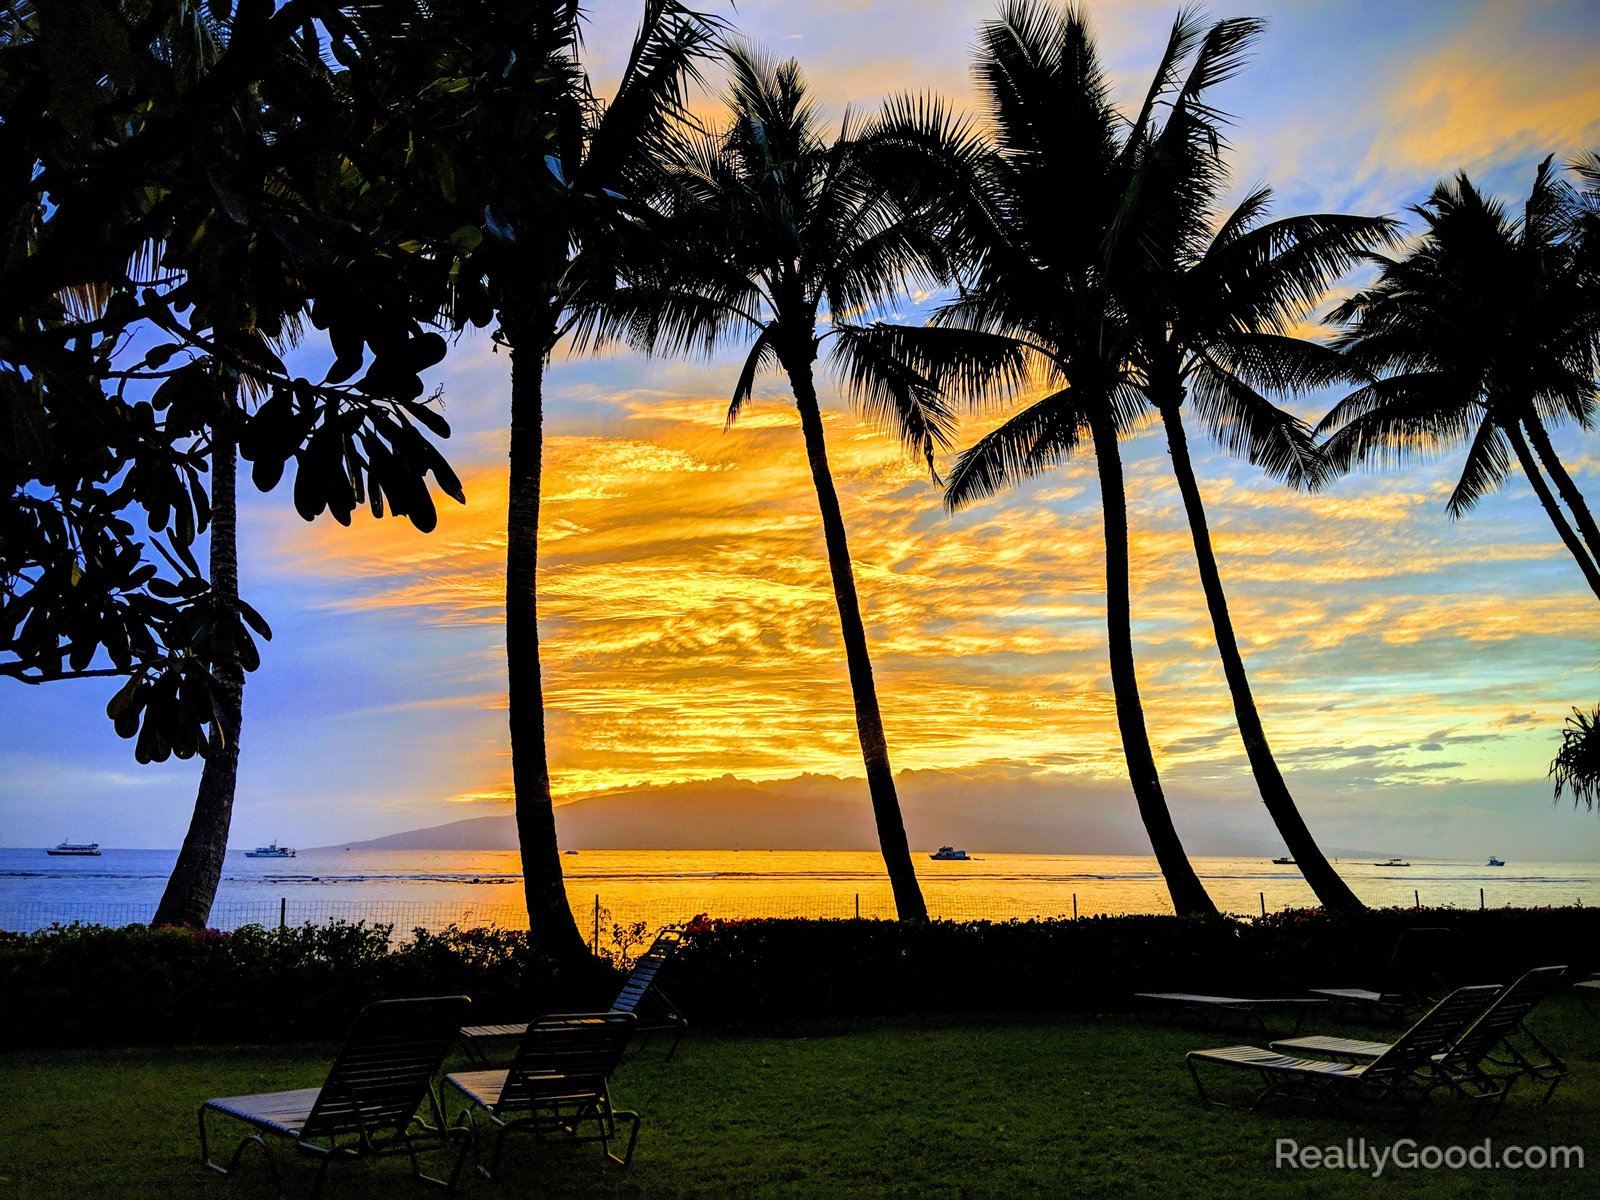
198 995 470 1197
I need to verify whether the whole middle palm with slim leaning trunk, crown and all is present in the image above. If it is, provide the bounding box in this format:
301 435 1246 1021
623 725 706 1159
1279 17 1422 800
576 46 950 920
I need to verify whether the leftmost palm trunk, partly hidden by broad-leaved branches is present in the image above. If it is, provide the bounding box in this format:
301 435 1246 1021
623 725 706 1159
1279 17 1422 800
150 429 245 930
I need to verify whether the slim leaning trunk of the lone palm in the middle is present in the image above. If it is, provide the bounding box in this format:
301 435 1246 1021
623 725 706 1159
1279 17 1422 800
789 362 928 920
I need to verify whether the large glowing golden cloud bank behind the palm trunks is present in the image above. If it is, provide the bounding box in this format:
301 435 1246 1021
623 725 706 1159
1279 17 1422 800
268 361 1593 803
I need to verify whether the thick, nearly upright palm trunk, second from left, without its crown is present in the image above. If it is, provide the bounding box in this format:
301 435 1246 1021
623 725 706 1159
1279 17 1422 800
502 314 590 963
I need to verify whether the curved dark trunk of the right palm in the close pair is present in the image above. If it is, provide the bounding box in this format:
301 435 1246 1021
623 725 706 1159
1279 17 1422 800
1160 405 1366 910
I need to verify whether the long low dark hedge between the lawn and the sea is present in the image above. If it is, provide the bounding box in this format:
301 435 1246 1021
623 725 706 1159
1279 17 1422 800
0 907 1600 1046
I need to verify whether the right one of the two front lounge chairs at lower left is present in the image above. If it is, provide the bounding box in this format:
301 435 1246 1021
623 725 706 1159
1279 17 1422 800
445 1013 638 1178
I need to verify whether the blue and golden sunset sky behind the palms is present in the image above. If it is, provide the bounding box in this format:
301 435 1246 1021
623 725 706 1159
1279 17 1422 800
0 0 1600 859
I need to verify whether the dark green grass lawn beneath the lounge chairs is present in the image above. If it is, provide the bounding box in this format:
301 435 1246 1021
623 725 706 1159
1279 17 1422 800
0 1000 1600 1200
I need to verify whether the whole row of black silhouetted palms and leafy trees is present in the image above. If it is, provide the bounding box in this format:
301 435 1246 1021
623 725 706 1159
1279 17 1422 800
0 0 1600 958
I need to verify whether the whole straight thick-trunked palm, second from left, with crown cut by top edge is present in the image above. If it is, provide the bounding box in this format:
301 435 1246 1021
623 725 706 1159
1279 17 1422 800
358 0 717 962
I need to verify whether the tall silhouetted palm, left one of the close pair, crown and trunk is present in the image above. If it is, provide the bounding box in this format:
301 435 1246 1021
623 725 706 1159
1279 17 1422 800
857 0 1258 915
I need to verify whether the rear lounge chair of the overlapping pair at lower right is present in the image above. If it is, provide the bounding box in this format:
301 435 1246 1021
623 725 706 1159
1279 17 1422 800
1272 966 1566 1101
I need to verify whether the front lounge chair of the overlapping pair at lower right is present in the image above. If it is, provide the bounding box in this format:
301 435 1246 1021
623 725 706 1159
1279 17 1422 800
1186 984 1501 1115
